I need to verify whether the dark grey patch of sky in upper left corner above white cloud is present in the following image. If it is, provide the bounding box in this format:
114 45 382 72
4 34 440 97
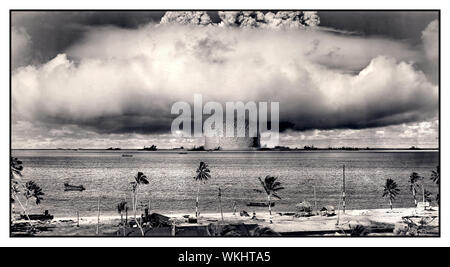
11 11 164 68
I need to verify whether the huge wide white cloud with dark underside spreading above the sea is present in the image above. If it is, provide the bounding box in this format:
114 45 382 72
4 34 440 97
12 14 438 136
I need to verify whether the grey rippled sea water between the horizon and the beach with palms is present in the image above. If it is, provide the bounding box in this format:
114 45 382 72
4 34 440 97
12 150 439 219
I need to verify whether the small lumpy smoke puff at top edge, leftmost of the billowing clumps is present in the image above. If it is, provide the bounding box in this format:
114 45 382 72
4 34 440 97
161 11 212 25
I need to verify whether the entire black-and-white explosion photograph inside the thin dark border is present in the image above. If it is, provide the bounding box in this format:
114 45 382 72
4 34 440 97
9 10 441 238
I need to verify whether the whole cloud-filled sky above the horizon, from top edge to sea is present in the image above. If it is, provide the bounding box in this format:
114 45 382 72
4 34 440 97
11 11 439 148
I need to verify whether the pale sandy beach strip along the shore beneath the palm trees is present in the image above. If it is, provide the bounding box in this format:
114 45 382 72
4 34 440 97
12 207 439 236
